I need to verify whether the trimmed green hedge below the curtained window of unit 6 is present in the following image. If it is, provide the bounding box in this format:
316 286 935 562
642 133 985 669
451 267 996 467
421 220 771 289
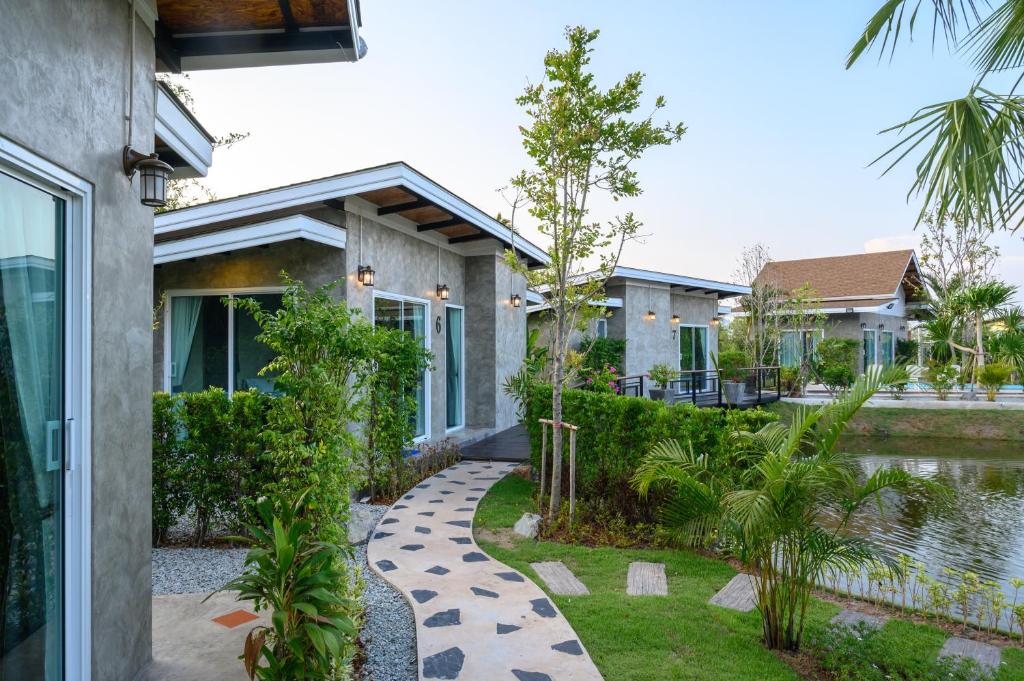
153 388 274 545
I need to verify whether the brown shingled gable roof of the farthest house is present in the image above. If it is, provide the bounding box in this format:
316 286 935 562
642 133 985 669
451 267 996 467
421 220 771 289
757 250 923 300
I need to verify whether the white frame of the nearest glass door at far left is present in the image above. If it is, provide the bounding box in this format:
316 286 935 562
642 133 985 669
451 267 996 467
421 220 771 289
0 136 93 681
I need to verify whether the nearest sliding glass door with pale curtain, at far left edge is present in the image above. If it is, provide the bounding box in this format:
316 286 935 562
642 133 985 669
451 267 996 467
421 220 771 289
0 166 67 681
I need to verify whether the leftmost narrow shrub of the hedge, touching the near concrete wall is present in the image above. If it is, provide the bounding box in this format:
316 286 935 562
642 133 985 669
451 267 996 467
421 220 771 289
153 392 184 544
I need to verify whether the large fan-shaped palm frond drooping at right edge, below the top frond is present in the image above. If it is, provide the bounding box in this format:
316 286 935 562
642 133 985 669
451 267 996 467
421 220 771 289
871 85 1024 228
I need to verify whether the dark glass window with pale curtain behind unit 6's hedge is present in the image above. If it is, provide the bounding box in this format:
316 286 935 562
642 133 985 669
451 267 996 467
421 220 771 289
169 293 282 393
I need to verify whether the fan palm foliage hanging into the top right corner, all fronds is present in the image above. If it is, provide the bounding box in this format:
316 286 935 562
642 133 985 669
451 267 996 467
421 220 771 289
847 0 1024 229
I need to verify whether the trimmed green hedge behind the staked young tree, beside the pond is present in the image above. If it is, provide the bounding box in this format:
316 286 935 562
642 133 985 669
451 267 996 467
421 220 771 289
526 385 778 519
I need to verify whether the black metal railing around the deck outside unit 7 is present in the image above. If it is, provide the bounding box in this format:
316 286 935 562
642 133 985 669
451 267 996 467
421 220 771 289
615 367 782 408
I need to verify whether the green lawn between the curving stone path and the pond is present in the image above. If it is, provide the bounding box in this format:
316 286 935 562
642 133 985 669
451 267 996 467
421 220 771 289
474 477 1024 681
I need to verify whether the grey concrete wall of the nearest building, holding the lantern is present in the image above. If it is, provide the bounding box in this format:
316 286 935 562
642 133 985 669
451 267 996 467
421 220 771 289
0 0 155 681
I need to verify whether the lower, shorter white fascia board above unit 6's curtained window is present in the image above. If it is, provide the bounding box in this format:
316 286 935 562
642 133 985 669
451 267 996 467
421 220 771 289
153 215 345 265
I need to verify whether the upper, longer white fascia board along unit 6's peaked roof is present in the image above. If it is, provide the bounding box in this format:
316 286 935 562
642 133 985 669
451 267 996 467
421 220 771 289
154 163 550 263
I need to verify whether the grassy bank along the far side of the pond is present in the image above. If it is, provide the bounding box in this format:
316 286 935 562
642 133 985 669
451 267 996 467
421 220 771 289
767 402 1024 441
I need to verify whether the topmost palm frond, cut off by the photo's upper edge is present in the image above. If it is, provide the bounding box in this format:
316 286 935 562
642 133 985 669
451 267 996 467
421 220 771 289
846 0 981 69
